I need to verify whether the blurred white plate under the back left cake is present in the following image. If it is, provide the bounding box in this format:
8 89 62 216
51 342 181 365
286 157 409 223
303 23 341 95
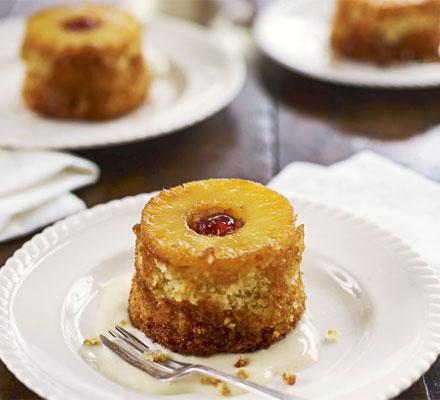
0 17 245 149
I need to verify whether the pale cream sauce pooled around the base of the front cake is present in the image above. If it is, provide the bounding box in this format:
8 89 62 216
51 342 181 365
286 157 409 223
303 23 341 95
80 275 320 394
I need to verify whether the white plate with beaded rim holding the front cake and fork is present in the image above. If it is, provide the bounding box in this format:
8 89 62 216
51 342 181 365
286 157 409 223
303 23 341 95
0 195 440 400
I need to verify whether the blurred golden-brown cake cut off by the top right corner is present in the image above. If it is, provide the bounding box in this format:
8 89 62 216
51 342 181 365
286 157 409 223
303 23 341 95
330 0 440 64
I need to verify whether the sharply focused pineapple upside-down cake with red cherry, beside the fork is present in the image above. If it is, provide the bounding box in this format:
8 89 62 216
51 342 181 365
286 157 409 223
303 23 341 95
129 179 305 355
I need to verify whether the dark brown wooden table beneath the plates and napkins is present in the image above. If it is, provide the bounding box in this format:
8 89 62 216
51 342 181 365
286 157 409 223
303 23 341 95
0 7 440 400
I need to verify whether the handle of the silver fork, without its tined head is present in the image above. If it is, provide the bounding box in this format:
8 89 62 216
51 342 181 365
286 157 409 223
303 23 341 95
188 365 306 400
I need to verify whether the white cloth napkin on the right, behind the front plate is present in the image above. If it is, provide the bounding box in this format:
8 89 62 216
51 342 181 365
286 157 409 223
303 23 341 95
269 151 440 274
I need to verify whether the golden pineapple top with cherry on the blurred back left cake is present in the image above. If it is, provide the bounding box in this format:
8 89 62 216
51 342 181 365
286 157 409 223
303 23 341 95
24 4 142 54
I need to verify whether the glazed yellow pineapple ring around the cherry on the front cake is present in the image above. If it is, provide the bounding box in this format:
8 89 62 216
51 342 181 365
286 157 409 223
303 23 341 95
140 179 296 266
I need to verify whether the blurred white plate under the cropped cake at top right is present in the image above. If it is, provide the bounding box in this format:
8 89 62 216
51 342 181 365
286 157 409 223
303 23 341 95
255 0 440 88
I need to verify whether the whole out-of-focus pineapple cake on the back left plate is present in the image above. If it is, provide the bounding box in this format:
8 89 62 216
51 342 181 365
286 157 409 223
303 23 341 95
22 4 148 120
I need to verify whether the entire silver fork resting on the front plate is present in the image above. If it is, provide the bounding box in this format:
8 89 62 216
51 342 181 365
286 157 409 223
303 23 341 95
100 325 305 400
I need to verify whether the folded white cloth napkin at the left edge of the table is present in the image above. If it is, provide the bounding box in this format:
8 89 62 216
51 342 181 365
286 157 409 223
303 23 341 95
0 149 99 242
